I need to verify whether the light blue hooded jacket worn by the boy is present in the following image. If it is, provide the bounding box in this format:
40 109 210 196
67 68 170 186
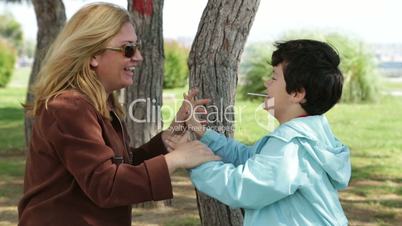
190 116 351 226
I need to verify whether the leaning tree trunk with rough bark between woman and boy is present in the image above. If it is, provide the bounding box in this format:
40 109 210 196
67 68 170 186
188 0 260 226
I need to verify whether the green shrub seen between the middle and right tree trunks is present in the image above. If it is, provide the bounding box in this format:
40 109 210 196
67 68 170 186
163 41 189 89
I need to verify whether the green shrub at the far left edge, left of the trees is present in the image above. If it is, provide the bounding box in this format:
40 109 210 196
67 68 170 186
0 38 16 88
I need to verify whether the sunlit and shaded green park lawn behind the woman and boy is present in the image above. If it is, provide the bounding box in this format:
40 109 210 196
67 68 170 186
0 69 402 226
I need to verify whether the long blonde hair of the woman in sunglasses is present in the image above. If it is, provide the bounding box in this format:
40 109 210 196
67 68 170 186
26 3 133 119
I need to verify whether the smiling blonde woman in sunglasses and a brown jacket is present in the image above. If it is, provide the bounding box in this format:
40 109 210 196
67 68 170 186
18 3 218 226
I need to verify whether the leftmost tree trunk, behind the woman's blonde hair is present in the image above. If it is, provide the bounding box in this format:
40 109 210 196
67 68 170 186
25 0 66 148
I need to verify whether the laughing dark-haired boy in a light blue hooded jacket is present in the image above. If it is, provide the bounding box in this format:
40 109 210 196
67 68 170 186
188 40 351 226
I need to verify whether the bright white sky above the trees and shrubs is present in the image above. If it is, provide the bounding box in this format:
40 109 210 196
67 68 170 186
0 0 402 43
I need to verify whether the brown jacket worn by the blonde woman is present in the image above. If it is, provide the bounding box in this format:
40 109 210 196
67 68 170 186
18 91 173 226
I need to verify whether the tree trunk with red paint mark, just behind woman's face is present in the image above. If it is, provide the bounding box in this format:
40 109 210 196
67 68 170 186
123 0 171 207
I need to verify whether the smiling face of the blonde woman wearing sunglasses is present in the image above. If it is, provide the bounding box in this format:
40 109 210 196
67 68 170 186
91 23 143 94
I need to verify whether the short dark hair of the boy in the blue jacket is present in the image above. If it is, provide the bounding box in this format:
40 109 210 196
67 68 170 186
271 39 343 115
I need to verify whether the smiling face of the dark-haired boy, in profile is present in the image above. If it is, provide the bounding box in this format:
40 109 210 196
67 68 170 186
265 63 293 116
